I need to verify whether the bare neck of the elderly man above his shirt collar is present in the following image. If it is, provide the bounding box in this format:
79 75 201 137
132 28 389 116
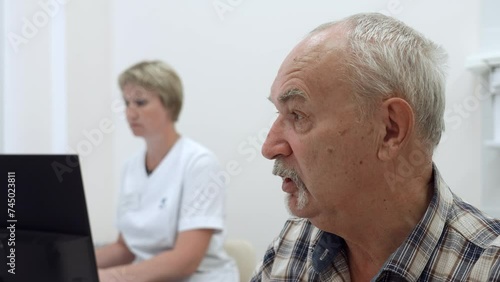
339 163 434 281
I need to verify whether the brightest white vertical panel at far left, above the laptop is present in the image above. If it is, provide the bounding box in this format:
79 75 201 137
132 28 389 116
2 1 52 153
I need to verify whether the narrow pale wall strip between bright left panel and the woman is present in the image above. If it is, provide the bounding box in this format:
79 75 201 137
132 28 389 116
66 0 117 247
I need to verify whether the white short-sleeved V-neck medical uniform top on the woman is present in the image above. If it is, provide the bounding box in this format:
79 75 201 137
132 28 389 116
117 137 239 282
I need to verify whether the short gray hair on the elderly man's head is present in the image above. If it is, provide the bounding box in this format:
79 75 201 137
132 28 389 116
311 13 447 152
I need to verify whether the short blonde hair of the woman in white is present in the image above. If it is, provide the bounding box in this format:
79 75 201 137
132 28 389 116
118 60 183 121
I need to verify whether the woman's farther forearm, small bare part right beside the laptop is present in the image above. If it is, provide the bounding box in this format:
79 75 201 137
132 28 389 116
95 234 135 268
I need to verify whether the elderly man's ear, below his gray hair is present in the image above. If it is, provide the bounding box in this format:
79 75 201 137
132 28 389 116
378 97 415 161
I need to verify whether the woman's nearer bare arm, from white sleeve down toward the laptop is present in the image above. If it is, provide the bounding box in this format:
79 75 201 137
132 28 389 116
99 229 214 282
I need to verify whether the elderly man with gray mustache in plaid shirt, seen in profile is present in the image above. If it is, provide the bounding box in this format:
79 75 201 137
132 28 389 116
252 14 500 281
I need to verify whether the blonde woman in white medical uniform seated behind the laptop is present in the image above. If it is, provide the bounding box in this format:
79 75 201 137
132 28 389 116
96 61 238 282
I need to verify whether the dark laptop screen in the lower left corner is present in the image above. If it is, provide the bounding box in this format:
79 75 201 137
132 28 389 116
0 155 98 282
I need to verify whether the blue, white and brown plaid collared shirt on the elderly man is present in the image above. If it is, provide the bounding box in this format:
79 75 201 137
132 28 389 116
251 169 500 282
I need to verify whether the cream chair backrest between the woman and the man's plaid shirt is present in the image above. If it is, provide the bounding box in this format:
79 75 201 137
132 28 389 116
224 239 257 282
